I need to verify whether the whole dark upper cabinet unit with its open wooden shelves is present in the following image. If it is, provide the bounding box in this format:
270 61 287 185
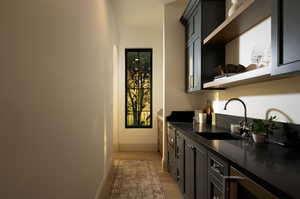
181 0 300 89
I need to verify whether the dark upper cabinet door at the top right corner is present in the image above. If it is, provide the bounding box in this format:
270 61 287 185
272 0 300 75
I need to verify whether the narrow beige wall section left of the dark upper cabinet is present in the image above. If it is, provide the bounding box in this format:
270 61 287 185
164 1 204 116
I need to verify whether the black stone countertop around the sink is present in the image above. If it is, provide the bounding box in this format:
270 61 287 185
170 122 300 199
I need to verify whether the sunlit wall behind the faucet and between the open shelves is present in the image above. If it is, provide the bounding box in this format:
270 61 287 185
205 2 300 124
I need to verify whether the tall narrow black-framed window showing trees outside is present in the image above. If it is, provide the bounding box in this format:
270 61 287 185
125 49 152 128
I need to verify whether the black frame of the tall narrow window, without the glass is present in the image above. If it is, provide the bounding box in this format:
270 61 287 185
125 48 153 129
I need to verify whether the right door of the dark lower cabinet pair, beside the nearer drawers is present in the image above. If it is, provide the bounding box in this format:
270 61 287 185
195 146 208 199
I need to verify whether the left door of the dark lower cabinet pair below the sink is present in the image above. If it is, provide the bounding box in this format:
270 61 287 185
184 140 195 199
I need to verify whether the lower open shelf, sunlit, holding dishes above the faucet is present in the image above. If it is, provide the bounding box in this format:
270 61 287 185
203 67 271 88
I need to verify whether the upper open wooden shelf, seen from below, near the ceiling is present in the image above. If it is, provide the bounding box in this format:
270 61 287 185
203 0 272 44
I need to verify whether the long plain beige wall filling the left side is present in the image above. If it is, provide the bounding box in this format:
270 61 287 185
0 0 116 199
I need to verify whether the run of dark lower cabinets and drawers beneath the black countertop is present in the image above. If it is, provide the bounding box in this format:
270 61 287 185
168 126 278 199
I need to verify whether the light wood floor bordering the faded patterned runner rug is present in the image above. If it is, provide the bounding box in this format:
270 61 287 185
112 152 183 199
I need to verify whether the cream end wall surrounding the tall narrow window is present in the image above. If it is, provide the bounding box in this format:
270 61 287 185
114 0 163 151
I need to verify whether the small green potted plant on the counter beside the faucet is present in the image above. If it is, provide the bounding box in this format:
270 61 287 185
251 116 277 143
